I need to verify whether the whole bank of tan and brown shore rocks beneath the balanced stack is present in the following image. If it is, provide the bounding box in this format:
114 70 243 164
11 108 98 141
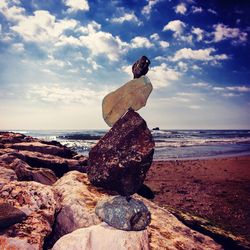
0 132 246 250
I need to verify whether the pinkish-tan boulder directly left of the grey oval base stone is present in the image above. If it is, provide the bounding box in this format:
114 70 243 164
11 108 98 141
51 171 104 244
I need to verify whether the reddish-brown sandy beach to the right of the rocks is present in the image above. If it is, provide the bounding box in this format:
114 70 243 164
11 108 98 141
145 156 250 239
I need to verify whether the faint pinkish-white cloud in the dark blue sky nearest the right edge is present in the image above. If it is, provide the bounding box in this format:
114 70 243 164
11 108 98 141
213 23 247 43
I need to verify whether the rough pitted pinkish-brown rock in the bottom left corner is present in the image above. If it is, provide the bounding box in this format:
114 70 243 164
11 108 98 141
0 181 57 250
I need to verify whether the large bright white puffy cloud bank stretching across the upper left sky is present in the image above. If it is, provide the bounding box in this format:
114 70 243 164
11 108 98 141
11 10 127 62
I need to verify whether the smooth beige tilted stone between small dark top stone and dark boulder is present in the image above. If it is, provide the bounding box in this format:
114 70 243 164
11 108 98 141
102 76 153 127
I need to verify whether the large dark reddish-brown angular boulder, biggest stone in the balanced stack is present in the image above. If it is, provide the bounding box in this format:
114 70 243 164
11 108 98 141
87 110 154 195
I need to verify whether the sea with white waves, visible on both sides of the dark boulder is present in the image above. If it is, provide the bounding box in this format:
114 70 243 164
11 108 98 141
4 129 250 161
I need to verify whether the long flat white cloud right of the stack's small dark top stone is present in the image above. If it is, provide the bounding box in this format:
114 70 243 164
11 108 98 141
170 48 228 61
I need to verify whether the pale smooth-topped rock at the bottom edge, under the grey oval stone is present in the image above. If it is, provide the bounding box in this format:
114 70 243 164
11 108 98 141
52 223 149 250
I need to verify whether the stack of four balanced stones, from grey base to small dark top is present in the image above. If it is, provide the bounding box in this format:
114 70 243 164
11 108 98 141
87 56 155 231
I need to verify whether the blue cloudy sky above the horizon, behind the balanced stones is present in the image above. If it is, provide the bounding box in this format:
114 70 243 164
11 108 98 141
0 0 250 130
